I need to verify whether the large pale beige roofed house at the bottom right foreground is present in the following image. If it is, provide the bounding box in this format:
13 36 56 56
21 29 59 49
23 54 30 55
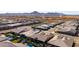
48 34 74 47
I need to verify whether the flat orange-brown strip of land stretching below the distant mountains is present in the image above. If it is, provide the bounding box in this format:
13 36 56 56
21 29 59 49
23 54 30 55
0 16 79 23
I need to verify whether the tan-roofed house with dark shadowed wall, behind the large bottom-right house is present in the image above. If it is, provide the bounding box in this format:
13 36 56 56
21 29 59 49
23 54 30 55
56 22 77 36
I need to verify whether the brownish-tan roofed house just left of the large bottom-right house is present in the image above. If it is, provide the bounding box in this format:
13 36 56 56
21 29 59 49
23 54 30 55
32 31 54 42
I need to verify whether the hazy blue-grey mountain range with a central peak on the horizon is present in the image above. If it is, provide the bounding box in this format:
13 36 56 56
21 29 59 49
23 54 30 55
0 11 65 16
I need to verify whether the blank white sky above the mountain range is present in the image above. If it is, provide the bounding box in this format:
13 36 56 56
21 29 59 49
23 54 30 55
0 0 79 14
